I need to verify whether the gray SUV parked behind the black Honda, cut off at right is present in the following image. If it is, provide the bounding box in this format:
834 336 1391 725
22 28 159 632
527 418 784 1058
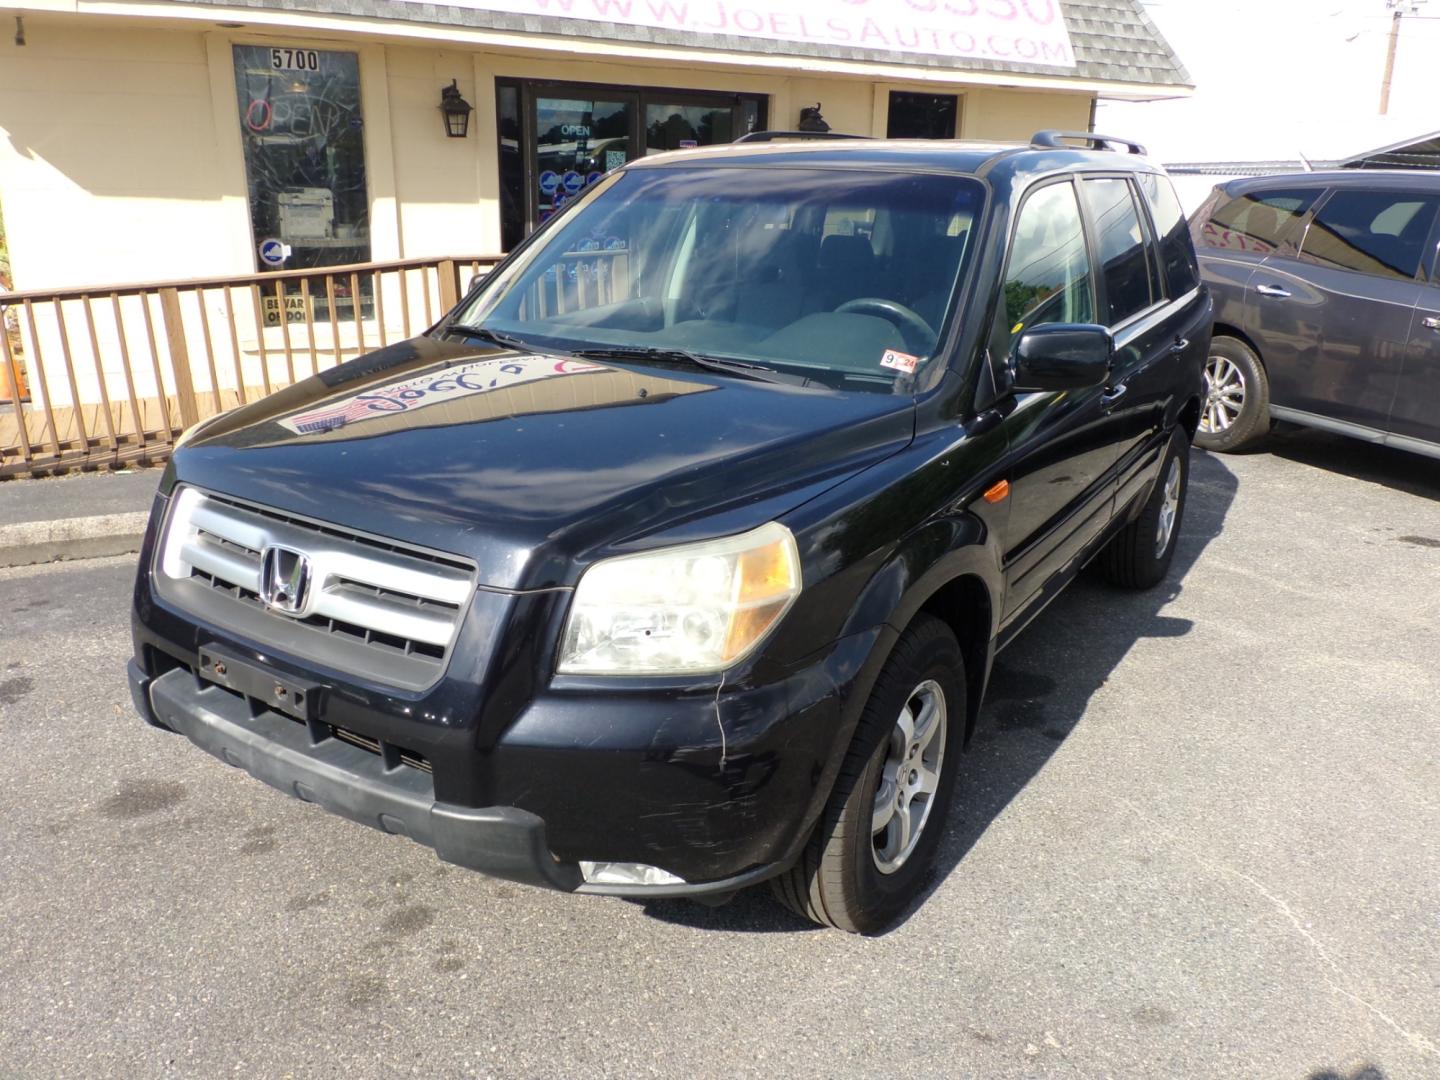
1191 171 1440 458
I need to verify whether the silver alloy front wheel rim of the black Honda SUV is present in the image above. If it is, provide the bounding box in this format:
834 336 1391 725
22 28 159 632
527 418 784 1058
870 678 948 874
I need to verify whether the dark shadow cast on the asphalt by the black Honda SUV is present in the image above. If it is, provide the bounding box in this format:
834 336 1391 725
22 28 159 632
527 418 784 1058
645 449 1237 933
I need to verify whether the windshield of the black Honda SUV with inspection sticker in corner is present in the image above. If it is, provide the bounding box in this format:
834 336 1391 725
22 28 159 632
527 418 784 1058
455 166 984 392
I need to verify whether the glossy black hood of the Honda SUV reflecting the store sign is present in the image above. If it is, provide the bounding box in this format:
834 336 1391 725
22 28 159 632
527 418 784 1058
173 337 914 589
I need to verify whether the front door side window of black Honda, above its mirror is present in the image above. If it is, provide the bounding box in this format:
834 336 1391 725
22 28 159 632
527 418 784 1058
991 181 1094 363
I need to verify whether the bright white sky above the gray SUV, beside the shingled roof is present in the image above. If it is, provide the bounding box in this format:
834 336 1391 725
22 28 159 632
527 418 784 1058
1096 0 1440 163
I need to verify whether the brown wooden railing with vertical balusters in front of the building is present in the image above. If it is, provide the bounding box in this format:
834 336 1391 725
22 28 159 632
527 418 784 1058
0 255 500 480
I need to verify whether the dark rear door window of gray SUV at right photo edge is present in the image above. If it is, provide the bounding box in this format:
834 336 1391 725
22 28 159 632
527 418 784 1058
1300 190 1436 279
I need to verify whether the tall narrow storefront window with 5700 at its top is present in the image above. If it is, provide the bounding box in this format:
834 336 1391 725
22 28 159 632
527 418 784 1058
235 45 370 271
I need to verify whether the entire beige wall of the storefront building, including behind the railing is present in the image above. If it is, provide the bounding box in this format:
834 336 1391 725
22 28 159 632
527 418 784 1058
0 14 1093 405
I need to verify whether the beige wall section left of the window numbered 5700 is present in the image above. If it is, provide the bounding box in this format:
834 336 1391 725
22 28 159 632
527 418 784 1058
0 20 249 288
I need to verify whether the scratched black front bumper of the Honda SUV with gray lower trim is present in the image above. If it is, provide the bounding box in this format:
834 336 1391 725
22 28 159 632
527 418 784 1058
130 480 875 897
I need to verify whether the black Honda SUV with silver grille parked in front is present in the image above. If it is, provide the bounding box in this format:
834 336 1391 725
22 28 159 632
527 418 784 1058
130 132 1211 932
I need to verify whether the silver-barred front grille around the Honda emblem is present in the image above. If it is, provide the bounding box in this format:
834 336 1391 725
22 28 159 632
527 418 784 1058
158 488 475 687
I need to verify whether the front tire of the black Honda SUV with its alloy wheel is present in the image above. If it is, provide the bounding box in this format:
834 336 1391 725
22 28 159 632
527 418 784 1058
773 615 966 933
